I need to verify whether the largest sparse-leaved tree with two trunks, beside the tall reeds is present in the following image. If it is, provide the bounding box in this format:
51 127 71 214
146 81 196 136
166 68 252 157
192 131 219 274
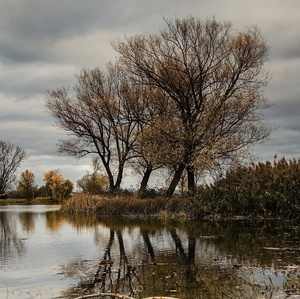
113 17 272 195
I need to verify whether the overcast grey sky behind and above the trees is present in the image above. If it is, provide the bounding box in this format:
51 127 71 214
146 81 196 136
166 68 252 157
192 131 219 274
0 0 300 190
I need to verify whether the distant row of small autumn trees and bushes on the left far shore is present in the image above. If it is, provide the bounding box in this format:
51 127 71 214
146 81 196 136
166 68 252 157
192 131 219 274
0 141 108 201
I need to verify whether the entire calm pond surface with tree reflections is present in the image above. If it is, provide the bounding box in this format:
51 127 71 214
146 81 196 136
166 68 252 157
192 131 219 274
0 205 300 299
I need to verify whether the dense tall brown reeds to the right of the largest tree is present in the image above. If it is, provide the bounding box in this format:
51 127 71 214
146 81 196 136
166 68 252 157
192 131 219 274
193 158 300 217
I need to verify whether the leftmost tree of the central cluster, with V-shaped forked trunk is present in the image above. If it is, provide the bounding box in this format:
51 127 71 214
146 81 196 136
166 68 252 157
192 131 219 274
46 65 141 191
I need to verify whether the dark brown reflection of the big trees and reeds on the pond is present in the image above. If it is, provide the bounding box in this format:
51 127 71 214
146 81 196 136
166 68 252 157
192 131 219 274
58 217 299 298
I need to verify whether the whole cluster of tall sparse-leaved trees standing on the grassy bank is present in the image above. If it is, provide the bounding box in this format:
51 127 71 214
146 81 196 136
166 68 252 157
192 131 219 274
46 17 273 196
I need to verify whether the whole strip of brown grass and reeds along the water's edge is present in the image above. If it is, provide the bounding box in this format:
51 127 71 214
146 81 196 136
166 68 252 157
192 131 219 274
62 158 300 220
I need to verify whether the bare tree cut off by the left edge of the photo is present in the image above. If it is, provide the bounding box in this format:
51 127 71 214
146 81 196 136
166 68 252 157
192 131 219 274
0 141 26 194
